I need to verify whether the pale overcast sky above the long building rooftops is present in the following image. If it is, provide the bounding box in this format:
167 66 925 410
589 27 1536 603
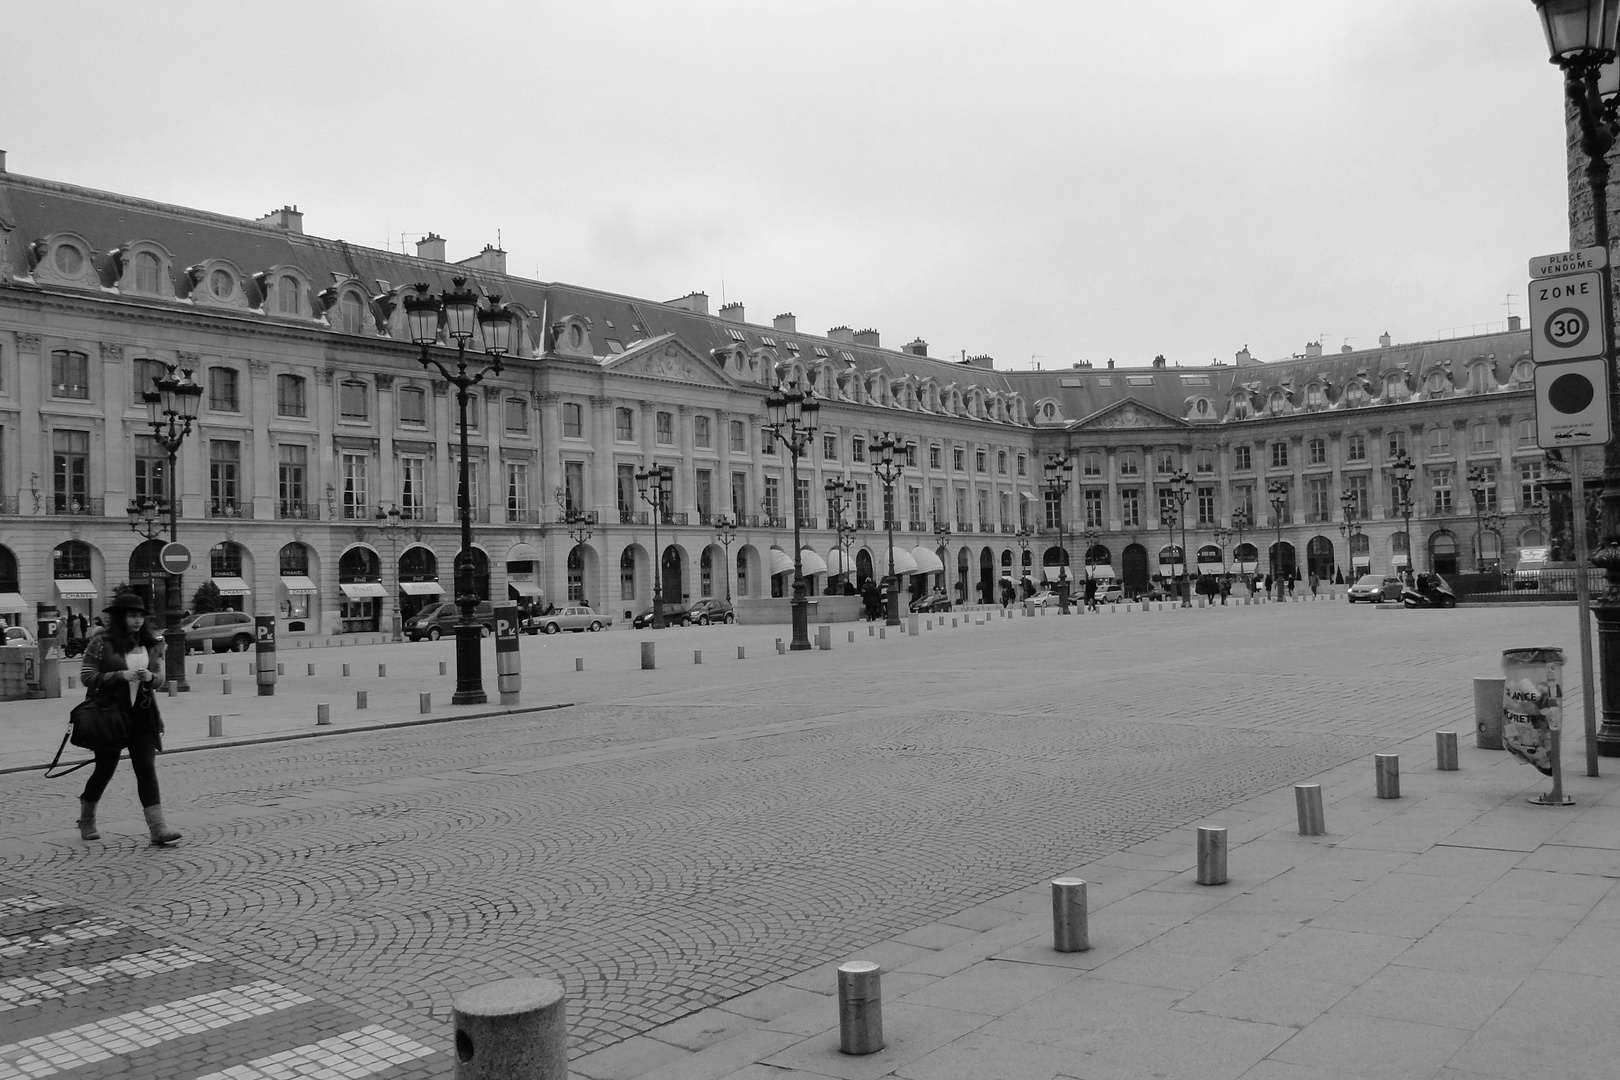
0 0 1568 368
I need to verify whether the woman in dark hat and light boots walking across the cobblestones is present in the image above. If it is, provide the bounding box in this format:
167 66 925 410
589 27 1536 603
79 593 180 844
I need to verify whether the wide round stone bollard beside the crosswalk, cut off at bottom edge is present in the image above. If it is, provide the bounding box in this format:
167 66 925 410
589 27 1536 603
450 978 569 1080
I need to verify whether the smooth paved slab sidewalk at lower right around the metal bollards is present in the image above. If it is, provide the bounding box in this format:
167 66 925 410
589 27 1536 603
570 711 1620 1080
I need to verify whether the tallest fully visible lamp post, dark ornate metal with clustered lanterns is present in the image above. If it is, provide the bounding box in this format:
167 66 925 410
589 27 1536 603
402 277 512 704
